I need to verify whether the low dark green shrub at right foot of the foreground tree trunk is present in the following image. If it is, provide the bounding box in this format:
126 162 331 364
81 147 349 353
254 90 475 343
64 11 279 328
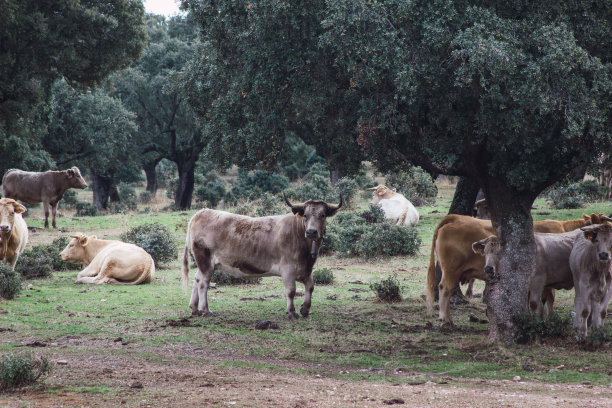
512 313 574 344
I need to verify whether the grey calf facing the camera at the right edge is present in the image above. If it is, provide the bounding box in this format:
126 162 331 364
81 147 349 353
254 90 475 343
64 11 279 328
570 222 612 339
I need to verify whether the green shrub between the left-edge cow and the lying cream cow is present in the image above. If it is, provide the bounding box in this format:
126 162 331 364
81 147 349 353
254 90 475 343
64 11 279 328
15 236 74 279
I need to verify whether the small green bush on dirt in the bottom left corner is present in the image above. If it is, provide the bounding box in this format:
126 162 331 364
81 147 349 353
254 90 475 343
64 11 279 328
0 354 52 391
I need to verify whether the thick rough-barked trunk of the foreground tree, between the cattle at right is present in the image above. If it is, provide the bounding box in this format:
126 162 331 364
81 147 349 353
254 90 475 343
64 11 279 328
485 180 536 344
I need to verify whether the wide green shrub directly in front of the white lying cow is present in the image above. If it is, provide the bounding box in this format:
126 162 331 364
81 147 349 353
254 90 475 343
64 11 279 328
355 222 421 258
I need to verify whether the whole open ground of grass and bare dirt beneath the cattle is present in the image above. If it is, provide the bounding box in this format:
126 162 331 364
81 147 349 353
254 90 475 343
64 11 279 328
0 185 612 407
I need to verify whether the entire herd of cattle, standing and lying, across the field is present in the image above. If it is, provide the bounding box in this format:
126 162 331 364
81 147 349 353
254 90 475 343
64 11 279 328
0 167 612 338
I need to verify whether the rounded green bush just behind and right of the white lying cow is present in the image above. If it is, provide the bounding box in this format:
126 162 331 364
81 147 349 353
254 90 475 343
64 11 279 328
385 167 438 206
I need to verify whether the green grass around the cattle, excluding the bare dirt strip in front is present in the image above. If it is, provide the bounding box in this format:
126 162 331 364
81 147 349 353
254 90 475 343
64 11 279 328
0 189 612 393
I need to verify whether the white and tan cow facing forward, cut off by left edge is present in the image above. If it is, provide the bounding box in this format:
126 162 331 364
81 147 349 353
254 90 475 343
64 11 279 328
0 198 28 270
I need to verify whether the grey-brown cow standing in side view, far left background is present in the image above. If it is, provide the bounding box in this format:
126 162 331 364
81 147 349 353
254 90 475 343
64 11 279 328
2 166 87 228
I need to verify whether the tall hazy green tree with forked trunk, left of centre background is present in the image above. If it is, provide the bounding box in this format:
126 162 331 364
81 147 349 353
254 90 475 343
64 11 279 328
113 15 204 209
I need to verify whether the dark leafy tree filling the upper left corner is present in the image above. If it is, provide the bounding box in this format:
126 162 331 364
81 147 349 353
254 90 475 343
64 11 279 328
0 0 146 173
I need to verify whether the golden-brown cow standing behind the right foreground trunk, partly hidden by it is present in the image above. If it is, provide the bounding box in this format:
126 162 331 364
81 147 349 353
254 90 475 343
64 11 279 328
427 214 597 324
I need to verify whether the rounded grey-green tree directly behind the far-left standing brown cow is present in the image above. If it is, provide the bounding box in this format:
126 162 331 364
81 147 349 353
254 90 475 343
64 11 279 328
43 83 137 209
